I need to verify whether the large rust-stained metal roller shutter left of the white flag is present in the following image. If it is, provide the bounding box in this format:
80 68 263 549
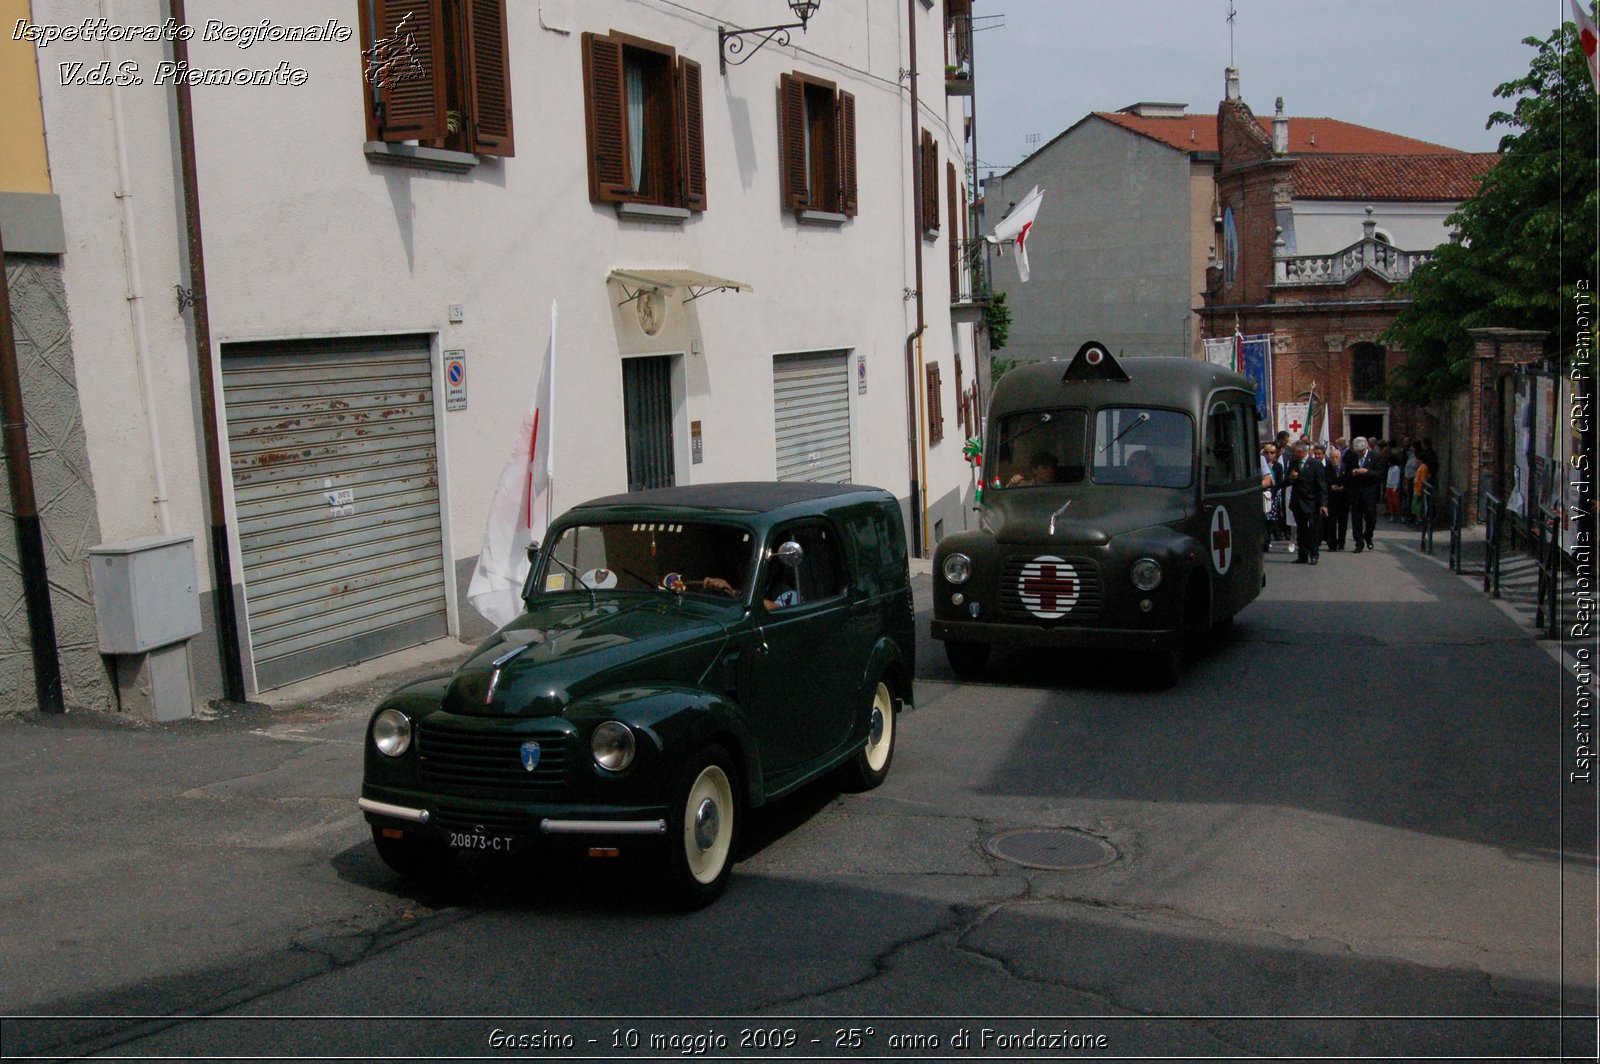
222 338 446 690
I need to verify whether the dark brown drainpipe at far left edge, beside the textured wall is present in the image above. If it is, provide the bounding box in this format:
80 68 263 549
0 219 67 714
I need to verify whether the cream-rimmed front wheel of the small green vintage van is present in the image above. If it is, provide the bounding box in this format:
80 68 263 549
664 746 739 909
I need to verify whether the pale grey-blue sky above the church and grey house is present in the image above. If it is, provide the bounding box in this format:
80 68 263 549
973 0 1571 174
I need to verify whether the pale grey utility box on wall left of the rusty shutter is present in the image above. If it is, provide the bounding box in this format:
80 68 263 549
90 536 200 654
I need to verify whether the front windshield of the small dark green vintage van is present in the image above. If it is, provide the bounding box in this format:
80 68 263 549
539 520 755 602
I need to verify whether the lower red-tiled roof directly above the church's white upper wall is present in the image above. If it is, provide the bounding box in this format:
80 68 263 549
1294 152 1499 202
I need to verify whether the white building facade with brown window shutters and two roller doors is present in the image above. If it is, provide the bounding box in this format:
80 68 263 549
21 0 976 699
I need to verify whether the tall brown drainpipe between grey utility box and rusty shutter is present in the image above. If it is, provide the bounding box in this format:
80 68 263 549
170 0 245 702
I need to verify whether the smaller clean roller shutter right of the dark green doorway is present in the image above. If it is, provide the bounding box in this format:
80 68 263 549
773 350 851 483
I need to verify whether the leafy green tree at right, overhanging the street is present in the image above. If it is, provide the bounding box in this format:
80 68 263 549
1381 14 1597 403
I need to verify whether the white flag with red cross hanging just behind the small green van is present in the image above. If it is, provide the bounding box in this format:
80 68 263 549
467 301 555 626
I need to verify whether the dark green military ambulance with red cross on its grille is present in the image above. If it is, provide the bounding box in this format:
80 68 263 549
933 342 1266 685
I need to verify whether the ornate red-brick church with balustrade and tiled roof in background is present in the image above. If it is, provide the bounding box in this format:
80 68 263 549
1197 70 1499 438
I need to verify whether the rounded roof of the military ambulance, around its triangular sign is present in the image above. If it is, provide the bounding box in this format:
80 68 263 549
989 355 1256 416
